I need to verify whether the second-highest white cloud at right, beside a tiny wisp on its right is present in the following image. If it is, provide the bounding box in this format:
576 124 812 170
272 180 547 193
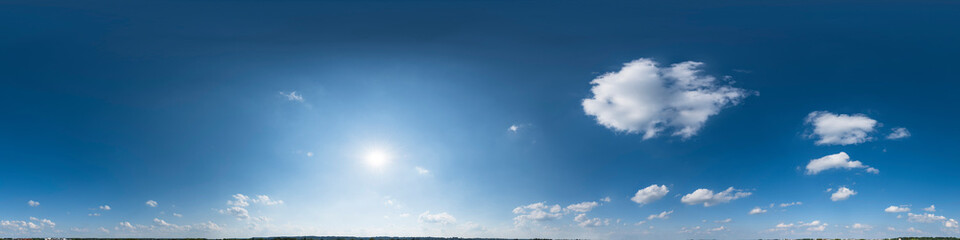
806 111 877 145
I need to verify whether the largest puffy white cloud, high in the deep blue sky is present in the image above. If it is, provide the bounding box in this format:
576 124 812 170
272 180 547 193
582 58 750 139
